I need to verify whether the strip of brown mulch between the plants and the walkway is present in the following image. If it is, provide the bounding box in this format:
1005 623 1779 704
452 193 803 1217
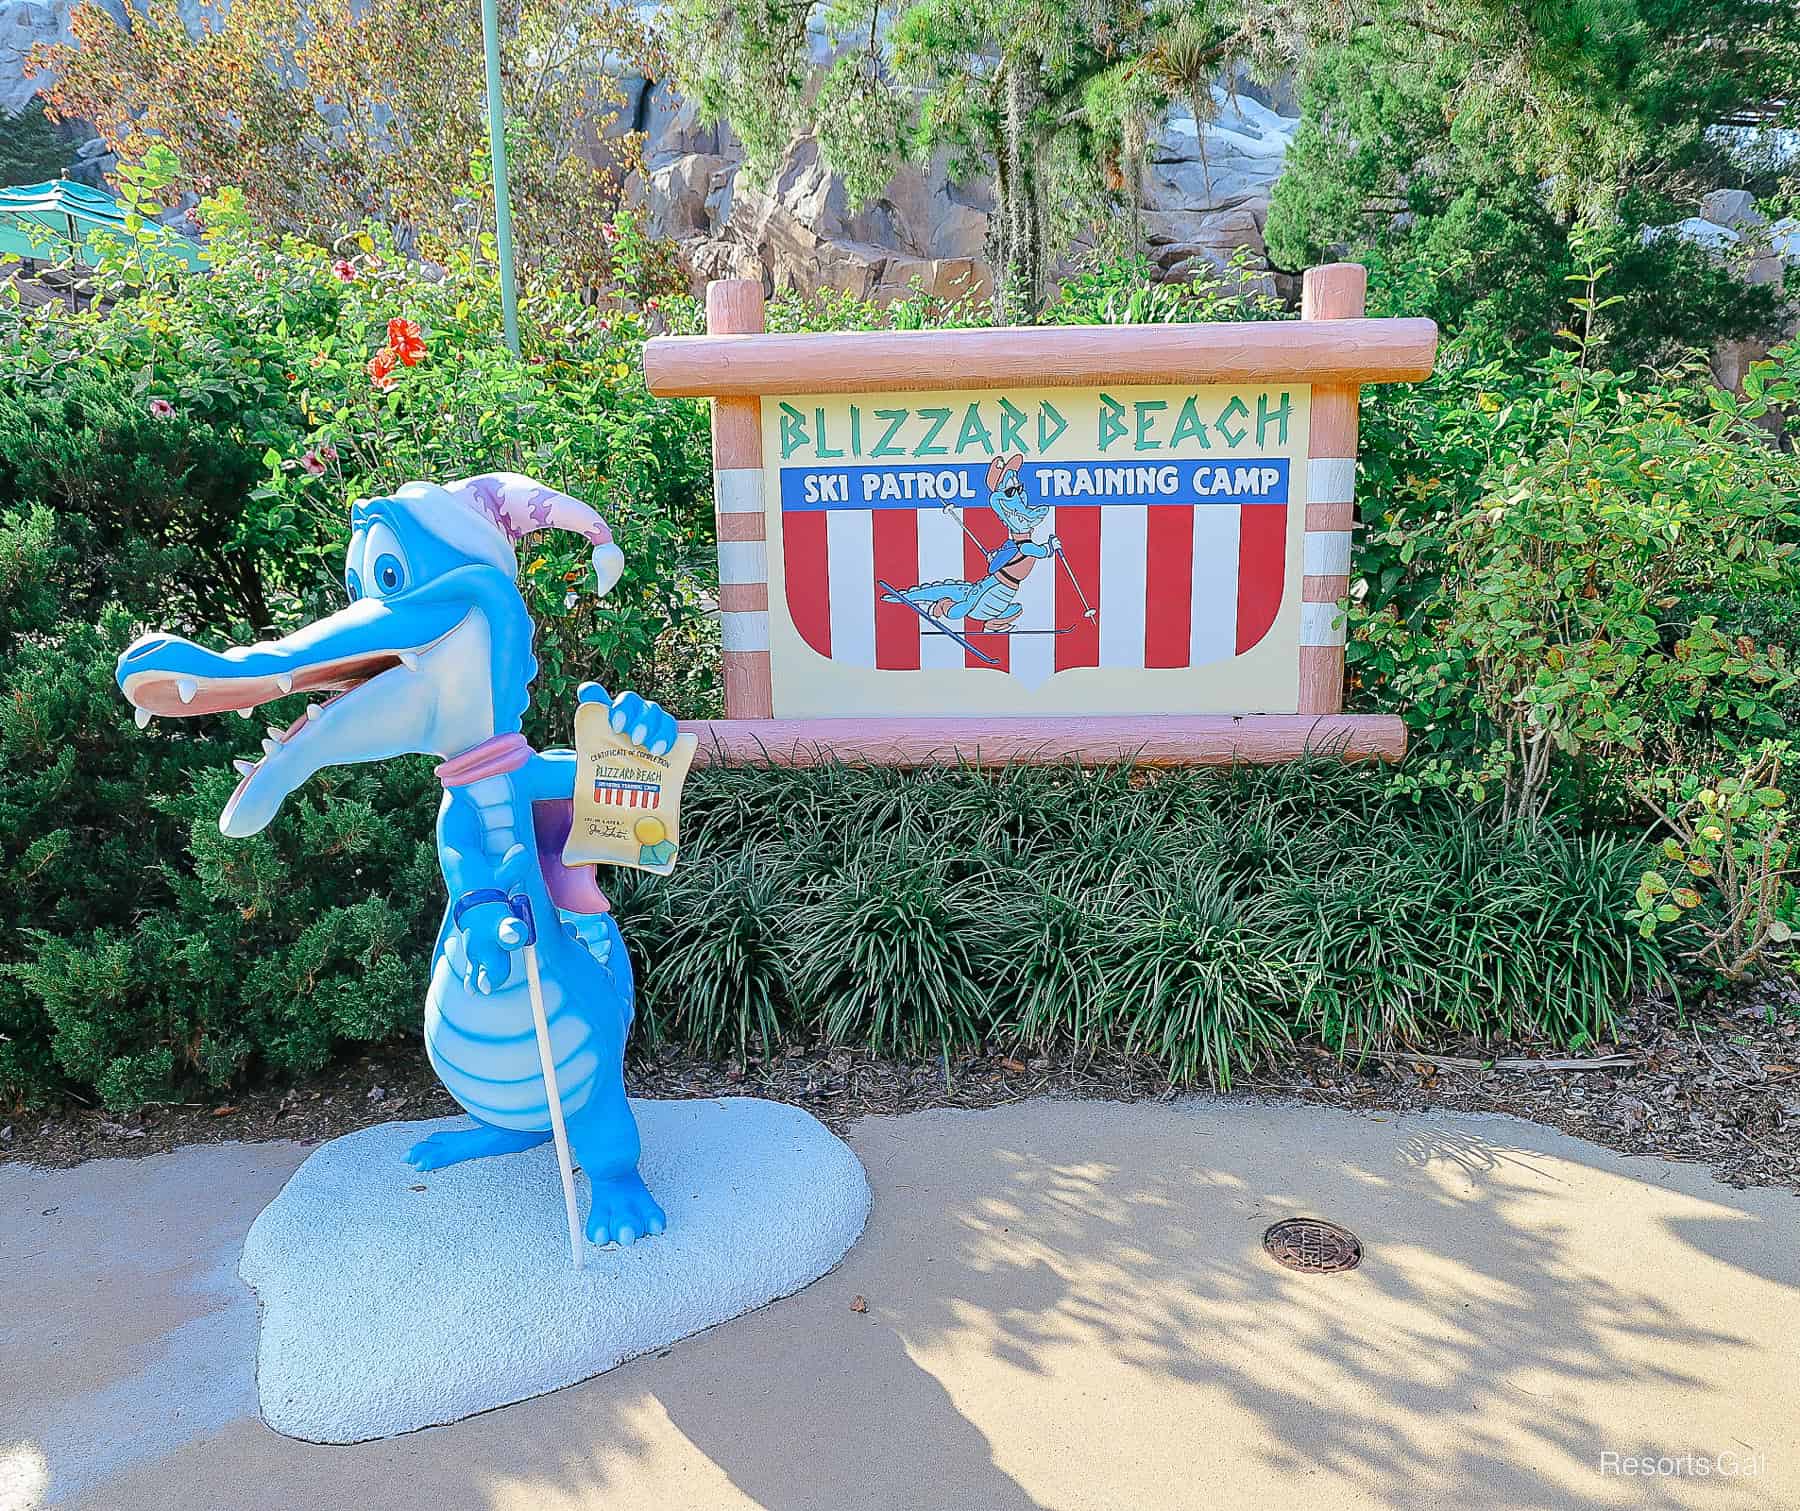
0 987 1800 1192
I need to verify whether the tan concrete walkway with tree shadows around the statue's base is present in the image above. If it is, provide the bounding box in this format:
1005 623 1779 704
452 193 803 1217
0 1099 1800 1511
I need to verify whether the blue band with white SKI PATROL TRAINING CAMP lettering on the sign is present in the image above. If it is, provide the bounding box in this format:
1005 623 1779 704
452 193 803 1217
781 456 1289 511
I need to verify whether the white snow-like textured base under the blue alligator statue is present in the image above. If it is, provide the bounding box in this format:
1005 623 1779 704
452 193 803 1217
238 1097 869 1443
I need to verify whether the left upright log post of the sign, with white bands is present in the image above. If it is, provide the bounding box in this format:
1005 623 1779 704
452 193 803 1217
706 277 774 719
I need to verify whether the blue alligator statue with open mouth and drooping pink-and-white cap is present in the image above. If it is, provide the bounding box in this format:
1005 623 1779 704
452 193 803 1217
119 474 677 1244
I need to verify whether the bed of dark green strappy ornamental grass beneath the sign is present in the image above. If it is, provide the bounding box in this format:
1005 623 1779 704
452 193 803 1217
614 764 1670 1084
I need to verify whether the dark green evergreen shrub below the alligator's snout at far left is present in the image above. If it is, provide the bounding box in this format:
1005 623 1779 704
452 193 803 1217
0 607 441 1108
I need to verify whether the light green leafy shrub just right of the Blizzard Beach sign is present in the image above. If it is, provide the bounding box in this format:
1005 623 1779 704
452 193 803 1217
1348 292 1800 818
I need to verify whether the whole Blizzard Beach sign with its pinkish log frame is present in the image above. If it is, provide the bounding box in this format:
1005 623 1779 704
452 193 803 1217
644 263 1436 765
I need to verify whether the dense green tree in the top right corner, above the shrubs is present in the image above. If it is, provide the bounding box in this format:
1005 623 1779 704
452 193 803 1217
1265 0 1800 360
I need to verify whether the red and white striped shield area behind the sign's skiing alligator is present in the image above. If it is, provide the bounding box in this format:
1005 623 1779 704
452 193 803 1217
781 482 1287 686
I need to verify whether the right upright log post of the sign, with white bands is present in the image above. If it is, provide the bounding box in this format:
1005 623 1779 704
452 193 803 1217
1300 263 1368 713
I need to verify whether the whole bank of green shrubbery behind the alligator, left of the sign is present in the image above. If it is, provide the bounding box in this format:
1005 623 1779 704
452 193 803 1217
0 196 716 1108
